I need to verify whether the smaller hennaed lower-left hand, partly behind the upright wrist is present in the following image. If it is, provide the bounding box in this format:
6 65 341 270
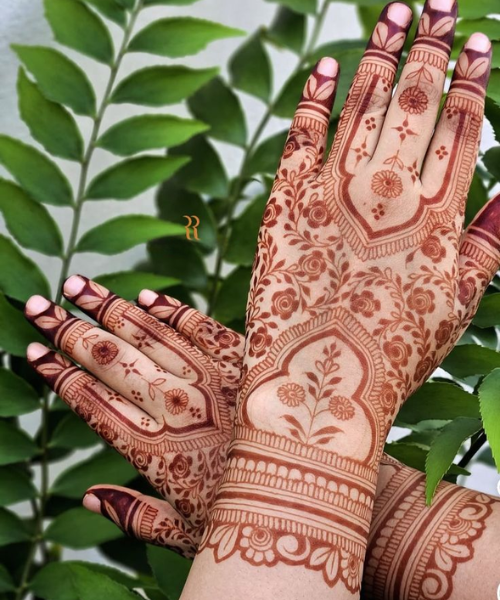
25 276 243 555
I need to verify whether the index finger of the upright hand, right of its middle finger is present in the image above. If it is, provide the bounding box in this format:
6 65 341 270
421 33 491 230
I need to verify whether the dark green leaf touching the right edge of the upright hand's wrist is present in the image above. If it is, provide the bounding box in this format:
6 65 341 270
397 382 480 424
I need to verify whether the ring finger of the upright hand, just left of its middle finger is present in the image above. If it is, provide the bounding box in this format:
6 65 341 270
323 2 412 174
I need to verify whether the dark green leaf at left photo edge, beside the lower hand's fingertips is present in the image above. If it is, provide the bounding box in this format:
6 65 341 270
0 293 47 357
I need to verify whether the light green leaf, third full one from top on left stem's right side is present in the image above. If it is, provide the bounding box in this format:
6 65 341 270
97 115 209 156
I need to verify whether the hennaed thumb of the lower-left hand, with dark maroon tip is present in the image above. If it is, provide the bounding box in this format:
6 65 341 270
83 485 198 558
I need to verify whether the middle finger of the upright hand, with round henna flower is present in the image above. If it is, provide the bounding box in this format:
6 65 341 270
373 0 457 172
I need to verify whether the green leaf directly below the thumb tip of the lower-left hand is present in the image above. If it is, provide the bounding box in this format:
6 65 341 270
44 507 123 550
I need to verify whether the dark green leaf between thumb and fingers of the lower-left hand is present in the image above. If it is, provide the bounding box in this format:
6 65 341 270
51 450 137 499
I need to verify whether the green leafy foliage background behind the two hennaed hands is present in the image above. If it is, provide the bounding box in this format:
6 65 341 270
0 0 500 600
